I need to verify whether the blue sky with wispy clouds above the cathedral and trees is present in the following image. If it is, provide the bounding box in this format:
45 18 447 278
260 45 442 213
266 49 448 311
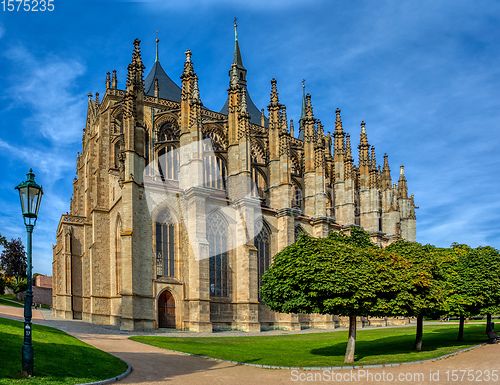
0 0 500 274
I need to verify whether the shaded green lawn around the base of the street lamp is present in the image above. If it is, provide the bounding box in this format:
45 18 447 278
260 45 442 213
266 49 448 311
0 318 127 385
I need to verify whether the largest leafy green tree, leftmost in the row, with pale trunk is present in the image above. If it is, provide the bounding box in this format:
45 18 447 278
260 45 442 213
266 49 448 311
260 228 394 363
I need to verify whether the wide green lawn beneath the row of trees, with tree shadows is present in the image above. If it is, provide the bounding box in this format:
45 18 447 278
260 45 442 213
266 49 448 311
130 324 487 367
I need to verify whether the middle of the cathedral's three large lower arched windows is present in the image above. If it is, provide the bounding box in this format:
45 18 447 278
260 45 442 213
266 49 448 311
207 214 231 297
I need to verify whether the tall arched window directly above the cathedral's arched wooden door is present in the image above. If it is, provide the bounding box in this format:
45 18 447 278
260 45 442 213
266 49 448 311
156 211 175 277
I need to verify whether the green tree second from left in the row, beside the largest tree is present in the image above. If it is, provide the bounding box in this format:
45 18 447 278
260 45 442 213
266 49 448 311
385 240 450 351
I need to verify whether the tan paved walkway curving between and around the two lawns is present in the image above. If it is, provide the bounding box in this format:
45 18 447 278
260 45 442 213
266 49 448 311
0 305 500 385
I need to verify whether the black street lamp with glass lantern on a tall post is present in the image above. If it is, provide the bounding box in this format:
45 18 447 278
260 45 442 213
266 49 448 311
16 168 43 377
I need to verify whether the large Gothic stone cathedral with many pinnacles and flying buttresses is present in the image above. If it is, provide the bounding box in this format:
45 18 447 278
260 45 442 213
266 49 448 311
53 25 416 332
